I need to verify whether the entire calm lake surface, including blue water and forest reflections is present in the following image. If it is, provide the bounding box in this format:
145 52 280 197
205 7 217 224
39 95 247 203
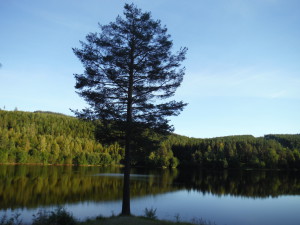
0 165 300 225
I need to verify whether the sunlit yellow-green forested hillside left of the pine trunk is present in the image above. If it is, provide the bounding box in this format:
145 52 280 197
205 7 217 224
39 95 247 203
0 110 124 165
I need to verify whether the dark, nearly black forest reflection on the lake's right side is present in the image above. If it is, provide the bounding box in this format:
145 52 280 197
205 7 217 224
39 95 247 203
173 170 300 198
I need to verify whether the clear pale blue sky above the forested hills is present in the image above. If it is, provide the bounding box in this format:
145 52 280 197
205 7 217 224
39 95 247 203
0 0 300 138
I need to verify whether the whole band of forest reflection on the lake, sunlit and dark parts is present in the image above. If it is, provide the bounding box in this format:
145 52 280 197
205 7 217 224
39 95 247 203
0 165 300 210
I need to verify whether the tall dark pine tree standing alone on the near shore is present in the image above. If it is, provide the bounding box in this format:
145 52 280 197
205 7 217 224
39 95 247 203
73 4 187 215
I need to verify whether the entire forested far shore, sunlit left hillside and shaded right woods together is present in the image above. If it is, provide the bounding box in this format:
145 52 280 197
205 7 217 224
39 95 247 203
0 110 300 169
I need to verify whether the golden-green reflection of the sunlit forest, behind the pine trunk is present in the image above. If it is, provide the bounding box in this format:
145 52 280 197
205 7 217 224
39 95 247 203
0 165 177 209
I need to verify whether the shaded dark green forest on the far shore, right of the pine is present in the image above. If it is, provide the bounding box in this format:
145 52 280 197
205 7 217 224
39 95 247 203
169 134 300 169
